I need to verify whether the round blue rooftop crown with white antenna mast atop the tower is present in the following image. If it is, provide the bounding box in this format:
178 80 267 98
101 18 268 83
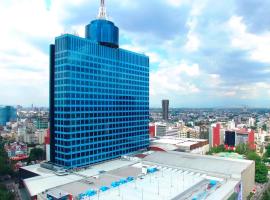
85 0 119 48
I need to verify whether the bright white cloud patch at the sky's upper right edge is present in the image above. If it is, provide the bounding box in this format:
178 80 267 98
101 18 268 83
228 16 270 63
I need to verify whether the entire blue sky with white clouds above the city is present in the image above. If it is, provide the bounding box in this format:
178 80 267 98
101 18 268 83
0 0 270 107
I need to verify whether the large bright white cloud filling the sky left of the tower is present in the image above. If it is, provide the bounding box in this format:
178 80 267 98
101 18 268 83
0 0 88 105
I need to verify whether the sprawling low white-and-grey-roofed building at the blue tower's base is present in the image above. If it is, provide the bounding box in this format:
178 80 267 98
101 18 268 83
20 152 255 200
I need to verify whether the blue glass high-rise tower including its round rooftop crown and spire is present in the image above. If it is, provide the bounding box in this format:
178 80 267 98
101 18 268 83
50 0 149 168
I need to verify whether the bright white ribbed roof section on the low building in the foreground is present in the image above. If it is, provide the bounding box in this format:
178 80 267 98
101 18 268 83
77 164 232 200
